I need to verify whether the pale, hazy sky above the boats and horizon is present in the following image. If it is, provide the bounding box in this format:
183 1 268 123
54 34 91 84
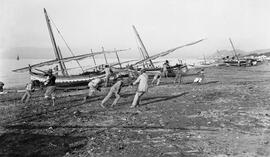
0 0 270 57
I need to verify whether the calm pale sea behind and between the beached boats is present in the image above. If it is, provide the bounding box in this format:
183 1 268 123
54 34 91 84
0 57 199 89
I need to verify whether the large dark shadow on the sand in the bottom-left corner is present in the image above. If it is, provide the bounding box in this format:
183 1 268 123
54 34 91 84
0 133 87 157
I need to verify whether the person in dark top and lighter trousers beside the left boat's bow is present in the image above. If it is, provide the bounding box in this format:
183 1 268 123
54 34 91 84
44 69 56 106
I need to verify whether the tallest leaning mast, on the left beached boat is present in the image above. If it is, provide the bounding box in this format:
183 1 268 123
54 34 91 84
44 8 68 76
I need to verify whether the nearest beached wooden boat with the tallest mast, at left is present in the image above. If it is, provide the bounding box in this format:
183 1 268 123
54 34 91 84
12 8 132 86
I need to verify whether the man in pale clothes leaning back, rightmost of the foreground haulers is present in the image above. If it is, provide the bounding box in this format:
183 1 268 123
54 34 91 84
130 69 148 108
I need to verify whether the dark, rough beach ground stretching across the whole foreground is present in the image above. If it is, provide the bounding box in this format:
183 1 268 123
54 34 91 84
0 65 270 157
